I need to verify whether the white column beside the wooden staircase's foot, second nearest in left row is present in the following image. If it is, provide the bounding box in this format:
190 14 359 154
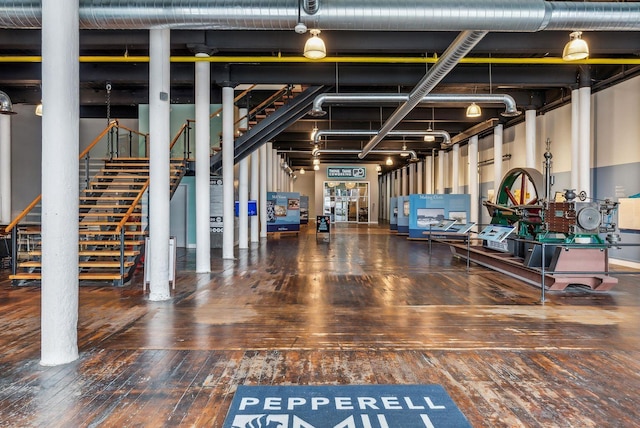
145 29 171 301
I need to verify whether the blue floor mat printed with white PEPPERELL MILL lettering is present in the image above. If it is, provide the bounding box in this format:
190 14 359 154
223 385 471 428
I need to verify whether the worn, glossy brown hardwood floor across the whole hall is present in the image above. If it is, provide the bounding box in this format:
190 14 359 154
0 226 640 427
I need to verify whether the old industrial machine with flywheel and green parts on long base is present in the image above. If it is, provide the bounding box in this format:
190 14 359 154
452 140 620 291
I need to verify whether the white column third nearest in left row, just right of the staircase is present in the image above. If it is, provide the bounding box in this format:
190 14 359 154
195 53 211 273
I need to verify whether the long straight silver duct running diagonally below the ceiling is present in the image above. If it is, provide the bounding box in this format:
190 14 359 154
358 31 487 159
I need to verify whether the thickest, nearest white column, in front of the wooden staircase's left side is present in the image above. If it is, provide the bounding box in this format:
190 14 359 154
40 0 80 366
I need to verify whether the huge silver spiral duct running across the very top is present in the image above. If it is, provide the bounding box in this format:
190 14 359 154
0 0 640 32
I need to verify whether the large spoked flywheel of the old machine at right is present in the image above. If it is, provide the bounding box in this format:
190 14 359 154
485 168 544 237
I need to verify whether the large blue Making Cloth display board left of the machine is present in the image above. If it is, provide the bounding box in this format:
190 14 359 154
409 194 471 238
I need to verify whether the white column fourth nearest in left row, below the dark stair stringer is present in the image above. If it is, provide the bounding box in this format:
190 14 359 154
222 86 235 260
